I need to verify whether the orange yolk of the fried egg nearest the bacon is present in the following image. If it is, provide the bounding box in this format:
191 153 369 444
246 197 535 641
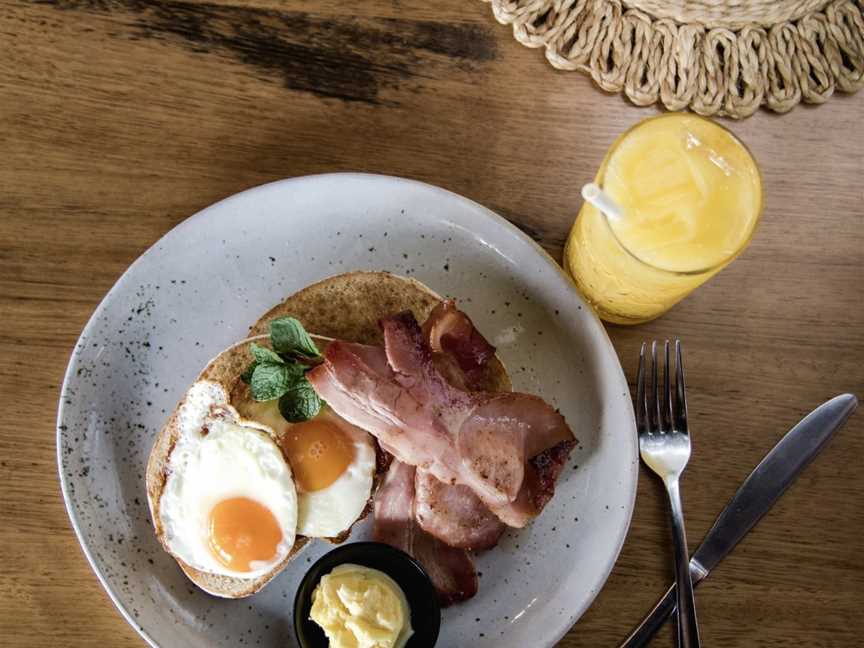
282 419 354 492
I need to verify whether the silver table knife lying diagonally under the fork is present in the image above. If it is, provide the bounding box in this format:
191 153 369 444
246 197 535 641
621 394 858 648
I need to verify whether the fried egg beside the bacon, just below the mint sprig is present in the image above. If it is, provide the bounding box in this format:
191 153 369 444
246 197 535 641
238 400 375 538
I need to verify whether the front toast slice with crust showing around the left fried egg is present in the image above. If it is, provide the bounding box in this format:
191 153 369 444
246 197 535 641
147 337 309 598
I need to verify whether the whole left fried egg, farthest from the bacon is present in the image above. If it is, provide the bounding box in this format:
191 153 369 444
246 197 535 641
159 380 298 579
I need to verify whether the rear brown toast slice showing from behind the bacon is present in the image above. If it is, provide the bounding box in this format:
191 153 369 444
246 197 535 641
249 271 511 391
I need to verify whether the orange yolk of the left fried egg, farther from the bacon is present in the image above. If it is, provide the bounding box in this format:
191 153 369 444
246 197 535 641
207 497 282 572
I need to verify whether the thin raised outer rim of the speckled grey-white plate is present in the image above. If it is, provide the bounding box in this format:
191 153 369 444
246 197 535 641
55 172 639 648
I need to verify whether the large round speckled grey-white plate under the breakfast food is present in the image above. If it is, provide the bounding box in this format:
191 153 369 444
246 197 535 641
57 174 638 648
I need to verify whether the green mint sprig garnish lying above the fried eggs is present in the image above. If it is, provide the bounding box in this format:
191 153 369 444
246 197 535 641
240 317 324 423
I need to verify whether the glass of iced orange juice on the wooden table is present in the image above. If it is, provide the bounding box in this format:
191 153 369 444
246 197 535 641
564 113 762 324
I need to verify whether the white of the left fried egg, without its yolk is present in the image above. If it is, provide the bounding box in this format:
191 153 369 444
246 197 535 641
159 381 298 579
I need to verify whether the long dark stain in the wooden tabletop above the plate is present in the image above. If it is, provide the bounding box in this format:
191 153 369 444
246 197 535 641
34 0 496 104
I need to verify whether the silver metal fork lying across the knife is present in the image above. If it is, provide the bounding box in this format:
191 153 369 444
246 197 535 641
636 340 700 648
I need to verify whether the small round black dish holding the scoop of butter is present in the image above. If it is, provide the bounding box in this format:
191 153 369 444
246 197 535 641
294 542 441 648
